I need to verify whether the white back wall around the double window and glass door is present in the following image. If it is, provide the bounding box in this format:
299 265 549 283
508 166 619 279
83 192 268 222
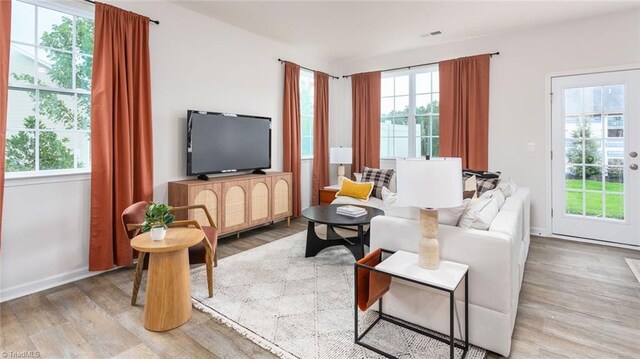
331 11 640 232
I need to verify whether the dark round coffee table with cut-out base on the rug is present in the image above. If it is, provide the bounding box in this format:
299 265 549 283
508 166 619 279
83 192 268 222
302 204 384 260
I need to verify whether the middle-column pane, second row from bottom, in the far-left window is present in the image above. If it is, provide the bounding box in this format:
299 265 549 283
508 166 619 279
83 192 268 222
40 91 76 130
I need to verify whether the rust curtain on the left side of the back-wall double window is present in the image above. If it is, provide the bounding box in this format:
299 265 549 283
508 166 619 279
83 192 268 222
351 71 381 174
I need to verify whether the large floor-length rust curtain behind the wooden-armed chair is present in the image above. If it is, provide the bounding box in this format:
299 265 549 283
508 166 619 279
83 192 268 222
89 3 153 271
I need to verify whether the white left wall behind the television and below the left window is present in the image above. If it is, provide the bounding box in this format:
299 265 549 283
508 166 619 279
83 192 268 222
0 1 333 300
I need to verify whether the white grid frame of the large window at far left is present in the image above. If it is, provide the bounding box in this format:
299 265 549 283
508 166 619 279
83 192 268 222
5 0 94 180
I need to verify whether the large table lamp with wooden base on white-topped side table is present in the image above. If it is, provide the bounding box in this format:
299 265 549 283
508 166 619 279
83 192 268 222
396 158 462 269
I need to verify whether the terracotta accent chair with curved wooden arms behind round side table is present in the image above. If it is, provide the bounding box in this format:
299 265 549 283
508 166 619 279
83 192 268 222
122 201 218 305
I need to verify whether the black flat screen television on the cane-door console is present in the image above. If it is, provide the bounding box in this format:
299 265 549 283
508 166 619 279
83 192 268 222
187 110 271 179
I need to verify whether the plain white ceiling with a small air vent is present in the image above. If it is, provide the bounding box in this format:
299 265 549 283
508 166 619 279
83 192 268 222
174 0 640 60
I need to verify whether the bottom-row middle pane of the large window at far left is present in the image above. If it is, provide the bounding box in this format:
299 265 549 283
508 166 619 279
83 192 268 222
38 131 74 170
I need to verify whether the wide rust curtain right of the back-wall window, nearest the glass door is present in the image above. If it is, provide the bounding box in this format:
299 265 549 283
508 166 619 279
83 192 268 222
439 54 491 170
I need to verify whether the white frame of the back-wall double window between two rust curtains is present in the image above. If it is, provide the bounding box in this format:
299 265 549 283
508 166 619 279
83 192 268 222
380 65 440 160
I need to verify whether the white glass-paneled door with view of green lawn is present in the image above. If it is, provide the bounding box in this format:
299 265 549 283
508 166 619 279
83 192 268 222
552 70 640 245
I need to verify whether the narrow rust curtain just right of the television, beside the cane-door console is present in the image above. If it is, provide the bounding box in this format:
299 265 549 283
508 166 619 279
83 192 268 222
282 62 302 217
